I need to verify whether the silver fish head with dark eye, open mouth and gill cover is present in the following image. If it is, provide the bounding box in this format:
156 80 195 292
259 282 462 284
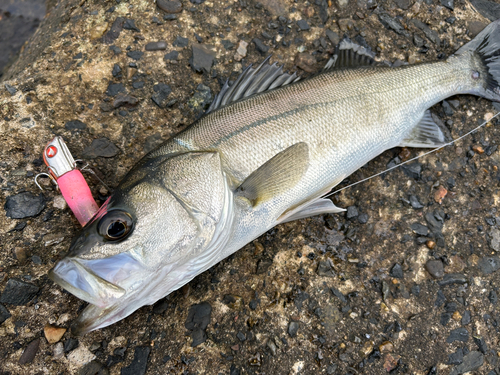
49 152 231 334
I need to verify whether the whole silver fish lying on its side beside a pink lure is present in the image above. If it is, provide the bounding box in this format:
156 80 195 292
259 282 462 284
49 20 500 335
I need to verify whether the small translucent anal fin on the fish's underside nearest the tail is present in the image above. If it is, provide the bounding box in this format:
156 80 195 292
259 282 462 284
399 110 445 148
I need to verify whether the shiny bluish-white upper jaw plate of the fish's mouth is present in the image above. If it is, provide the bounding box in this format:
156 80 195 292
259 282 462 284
48 258 125 309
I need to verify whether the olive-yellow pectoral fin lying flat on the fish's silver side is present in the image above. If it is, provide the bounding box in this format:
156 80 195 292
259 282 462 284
235 142 309 207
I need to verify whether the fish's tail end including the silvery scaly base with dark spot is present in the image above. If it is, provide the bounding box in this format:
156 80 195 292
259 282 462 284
449 19 500 102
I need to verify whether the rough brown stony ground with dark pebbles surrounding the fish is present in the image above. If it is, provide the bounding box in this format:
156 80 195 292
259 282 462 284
0 0 500 375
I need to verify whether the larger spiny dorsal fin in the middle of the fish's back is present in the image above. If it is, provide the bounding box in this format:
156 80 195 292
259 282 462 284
205 56 300 114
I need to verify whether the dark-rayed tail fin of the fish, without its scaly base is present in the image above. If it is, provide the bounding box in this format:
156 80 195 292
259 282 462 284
456 19 500 102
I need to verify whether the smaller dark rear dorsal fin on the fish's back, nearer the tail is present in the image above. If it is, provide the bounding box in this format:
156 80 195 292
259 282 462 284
323 36 375 70
